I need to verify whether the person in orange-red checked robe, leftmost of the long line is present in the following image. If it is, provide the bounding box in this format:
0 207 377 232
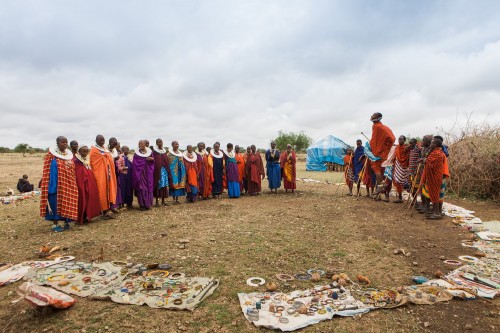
40 136 78 232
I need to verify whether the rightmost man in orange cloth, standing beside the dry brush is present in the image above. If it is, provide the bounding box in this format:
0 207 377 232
421 136 449 220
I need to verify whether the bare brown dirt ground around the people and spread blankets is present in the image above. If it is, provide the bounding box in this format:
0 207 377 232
0 154 500 332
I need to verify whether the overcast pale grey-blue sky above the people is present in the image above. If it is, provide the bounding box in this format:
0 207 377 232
0 0 500 148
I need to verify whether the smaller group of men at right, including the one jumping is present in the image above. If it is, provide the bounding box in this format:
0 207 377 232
344 113 450 220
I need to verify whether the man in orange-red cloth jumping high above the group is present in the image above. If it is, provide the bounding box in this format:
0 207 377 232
370 112 396 184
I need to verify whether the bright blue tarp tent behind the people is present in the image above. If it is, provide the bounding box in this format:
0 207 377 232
306 135 352 171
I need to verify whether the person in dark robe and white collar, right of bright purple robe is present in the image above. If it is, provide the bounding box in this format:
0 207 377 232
153 139 172 207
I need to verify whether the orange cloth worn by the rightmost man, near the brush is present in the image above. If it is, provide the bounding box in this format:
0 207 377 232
421 148 448 203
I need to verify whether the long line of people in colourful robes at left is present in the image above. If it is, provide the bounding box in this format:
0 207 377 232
40 135 296 232
